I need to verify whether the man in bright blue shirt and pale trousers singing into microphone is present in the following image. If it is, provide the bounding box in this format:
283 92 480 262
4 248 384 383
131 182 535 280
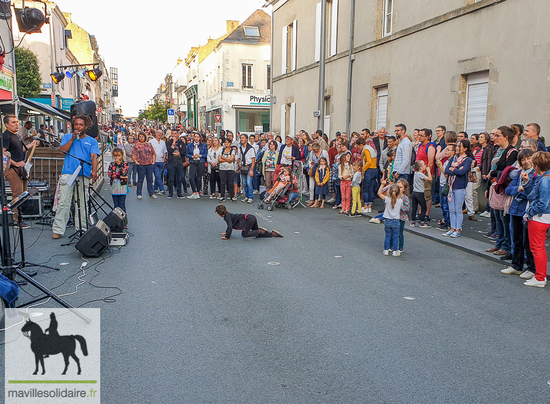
52 115 99 239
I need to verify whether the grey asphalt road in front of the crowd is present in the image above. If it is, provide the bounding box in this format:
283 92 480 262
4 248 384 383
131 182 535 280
0 188 550 404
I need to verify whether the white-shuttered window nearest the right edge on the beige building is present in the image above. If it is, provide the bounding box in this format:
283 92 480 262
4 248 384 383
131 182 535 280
464 71 489 133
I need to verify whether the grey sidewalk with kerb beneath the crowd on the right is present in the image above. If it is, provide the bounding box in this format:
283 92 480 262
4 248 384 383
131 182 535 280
362 198 550 265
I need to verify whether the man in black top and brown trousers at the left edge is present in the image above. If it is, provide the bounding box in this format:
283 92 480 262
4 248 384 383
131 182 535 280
2 115 40 229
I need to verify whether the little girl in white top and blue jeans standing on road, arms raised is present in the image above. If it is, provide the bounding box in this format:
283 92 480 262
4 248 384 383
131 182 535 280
378 181 403 257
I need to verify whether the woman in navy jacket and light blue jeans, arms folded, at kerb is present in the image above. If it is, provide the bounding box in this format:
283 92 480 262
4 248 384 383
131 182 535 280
443 139 473 238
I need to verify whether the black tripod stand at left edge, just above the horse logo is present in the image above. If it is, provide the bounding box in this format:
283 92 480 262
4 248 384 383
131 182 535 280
0 136 92 323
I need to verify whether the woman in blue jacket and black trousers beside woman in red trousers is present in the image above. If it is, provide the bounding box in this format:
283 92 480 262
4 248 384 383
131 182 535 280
500 149 537 279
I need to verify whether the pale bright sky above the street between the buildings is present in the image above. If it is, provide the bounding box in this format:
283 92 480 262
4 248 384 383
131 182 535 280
51 0 271 116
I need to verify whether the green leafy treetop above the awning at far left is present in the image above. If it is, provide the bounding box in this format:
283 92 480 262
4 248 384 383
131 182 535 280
15 48 42 98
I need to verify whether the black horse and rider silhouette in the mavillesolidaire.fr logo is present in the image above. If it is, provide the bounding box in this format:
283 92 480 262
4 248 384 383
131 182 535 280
21 313 88 375
